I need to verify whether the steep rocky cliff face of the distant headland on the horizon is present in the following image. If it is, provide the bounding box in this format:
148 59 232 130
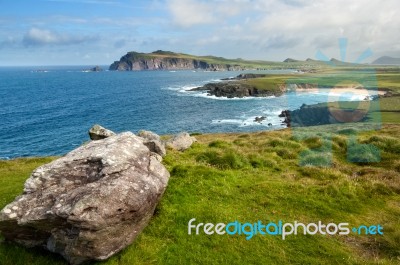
109 52 244 71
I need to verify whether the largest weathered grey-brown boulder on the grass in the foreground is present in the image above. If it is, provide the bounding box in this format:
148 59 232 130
0 132 169 264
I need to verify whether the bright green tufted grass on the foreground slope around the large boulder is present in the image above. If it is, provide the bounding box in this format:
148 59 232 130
0 124 400 265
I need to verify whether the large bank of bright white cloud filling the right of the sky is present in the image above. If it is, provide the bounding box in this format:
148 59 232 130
167 0 400 61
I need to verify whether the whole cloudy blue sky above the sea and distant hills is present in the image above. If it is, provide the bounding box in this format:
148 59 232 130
0 0 400 66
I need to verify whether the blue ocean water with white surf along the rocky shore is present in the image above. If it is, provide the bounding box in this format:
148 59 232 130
0 66 368 159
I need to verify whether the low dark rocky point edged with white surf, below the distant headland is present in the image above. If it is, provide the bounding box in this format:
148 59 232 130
191 81 283 98
